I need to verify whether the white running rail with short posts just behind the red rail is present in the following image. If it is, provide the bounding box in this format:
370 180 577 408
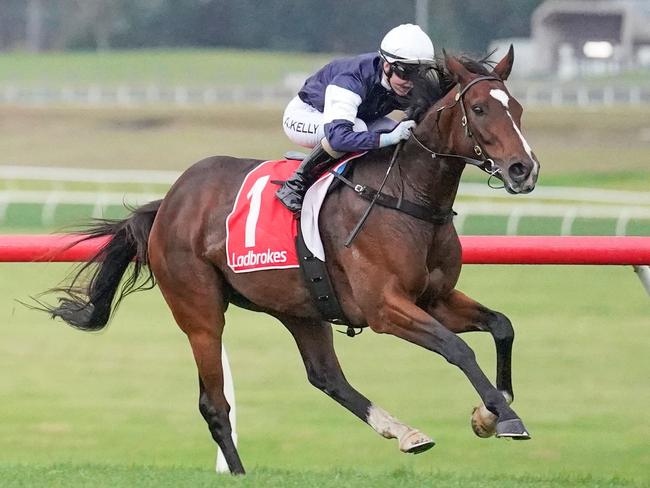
0 165 650 235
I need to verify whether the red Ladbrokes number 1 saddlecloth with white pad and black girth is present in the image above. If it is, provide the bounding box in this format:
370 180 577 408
226 152 364 324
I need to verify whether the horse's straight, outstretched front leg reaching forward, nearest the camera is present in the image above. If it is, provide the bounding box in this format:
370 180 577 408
368 290 530 439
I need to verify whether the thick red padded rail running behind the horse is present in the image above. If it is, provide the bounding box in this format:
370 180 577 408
0 235 650 265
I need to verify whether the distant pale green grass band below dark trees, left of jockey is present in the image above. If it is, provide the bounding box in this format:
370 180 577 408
0 49 331 87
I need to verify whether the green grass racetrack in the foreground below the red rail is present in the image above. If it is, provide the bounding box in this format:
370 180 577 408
0 264 650 487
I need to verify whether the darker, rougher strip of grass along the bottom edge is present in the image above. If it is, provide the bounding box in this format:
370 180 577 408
0 464 641 488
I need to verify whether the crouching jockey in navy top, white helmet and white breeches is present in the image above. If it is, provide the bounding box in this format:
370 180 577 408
276 24 434 213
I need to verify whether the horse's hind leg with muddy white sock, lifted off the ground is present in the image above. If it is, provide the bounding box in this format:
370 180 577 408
280 317 435 454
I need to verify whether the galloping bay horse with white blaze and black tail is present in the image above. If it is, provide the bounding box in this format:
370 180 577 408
38 46 539 474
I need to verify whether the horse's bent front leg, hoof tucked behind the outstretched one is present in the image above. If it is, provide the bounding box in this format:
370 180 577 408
426 290 515 437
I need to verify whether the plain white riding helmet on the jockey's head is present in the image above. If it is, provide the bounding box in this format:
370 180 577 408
379 24 434 64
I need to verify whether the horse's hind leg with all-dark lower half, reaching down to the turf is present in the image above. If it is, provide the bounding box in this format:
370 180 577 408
152 252 244 474
